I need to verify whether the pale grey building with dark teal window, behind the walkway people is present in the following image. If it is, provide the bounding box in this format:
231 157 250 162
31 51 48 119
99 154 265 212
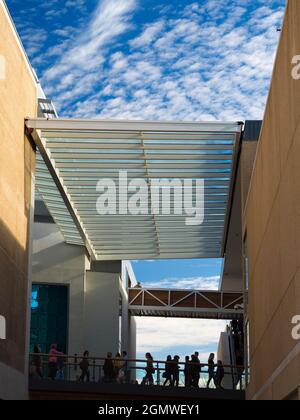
30 201 136 359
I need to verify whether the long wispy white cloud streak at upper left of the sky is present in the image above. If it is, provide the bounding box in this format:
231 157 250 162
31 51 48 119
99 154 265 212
43 0 136 101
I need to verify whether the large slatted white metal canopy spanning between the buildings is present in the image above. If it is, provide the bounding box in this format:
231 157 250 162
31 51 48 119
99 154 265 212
26 118 242 260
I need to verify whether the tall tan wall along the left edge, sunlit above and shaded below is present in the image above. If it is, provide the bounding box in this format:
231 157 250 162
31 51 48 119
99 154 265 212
0 0 37 399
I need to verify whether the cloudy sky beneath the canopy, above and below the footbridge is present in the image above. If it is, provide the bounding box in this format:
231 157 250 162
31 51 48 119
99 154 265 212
133 260 226 360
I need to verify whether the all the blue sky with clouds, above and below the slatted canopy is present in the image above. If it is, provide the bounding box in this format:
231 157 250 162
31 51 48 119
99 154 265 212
7 0 285 358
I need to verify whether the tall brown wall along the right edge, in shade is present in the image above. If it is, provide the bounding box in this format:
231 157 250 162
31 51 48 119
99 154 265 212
245 0 300 399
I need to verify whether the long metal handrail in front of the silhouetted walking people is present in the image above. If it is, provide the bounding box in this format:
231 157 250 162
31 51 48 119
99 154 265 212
29 353 246 390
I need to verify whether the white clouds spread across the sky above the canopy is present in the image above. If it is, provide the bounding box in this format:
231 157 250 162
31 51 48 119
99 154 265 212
22 0 283 120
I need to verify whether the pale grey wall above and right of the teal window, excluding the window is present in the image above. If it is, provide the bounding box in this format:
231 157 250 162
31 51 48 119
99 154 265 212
32 223 136 358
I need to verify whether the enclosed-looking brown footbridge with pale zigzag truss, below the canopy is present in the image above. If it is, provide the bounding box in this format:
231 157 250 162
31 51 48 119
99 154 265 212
129 288 244 320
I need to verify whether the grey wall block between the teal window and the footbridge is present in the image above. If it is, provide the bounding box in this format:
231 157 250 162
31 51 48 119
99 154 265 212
85 261 136 358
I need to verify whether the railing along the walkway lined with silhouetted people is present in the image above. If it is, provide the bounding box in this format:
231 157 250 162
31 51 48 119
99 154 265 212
29 353 246 390
